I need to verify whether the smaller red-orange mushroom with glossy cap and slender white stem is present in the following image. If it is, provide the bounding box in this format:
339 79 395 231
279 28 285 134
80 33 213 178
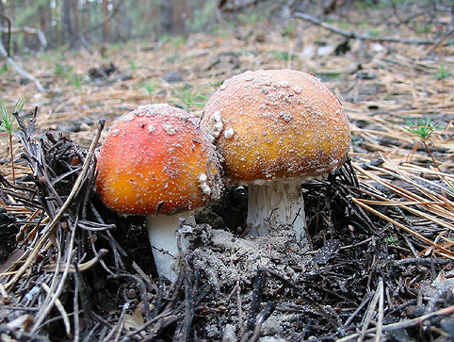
96 104 222 280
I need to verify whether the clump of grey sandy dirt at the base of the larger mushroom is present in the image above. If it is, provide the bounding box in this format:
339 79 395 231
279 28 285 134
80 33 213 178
189 225 311 293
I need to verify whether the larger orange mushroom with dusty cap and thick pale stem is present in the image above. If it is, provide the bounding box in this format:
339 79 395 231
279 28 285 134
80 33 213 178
201 70 350 242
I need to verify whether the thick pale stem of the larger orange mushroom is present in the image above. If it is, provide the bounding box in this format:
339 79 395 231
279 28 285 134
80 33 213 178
247 180 308 245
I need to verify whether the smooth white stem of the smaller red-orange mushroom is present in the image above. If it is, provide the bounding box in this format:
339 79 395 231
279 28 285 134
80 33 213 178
147 211 195 282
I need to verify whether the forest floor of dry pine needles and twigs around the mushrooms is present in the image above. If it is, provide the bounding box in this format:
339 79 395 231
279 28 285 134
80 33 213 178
0 9 454 342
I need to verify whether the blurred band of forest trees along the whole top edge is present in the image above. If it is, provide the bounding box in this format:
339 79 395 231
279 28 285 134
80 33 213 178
0 0 452 51
